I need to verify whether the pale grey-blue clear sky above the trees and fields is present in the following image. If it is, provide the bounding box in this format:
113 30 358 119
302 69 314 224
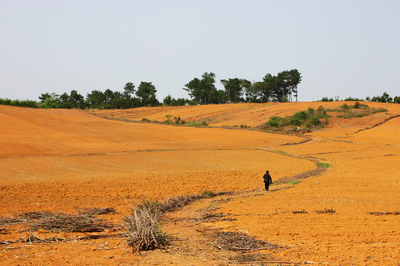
0 0 400 102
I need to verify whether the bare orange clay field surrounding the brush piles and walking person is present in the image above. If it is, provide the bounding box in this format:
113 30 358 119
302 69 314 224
0 102 400 265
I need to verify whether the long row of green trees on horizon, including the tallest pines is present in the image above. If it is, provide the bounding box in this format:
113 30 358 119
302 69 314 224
0 69 302 109
